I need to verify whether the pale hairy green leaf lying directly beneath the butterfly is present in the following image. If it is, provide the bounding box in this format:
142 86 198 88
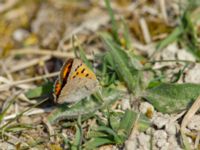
48 88 120 124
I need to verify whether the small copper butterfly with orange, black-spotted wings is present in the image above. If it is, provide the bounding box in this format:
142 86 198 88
53 59 99 104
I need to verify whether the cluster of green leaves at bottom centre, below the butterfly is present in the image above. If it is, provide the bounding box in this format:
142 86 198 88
84 110 150 149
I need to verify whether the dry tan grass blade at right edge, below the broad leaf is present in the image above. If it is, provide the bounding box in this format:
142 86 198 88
181 96 200 133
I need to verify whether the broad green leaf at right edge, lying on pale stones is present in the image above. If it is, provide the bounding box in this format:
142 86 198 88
143 83 200 113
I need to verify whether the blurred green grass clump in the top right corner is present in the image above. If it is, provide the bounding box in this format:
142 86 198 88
154 0 200 60
